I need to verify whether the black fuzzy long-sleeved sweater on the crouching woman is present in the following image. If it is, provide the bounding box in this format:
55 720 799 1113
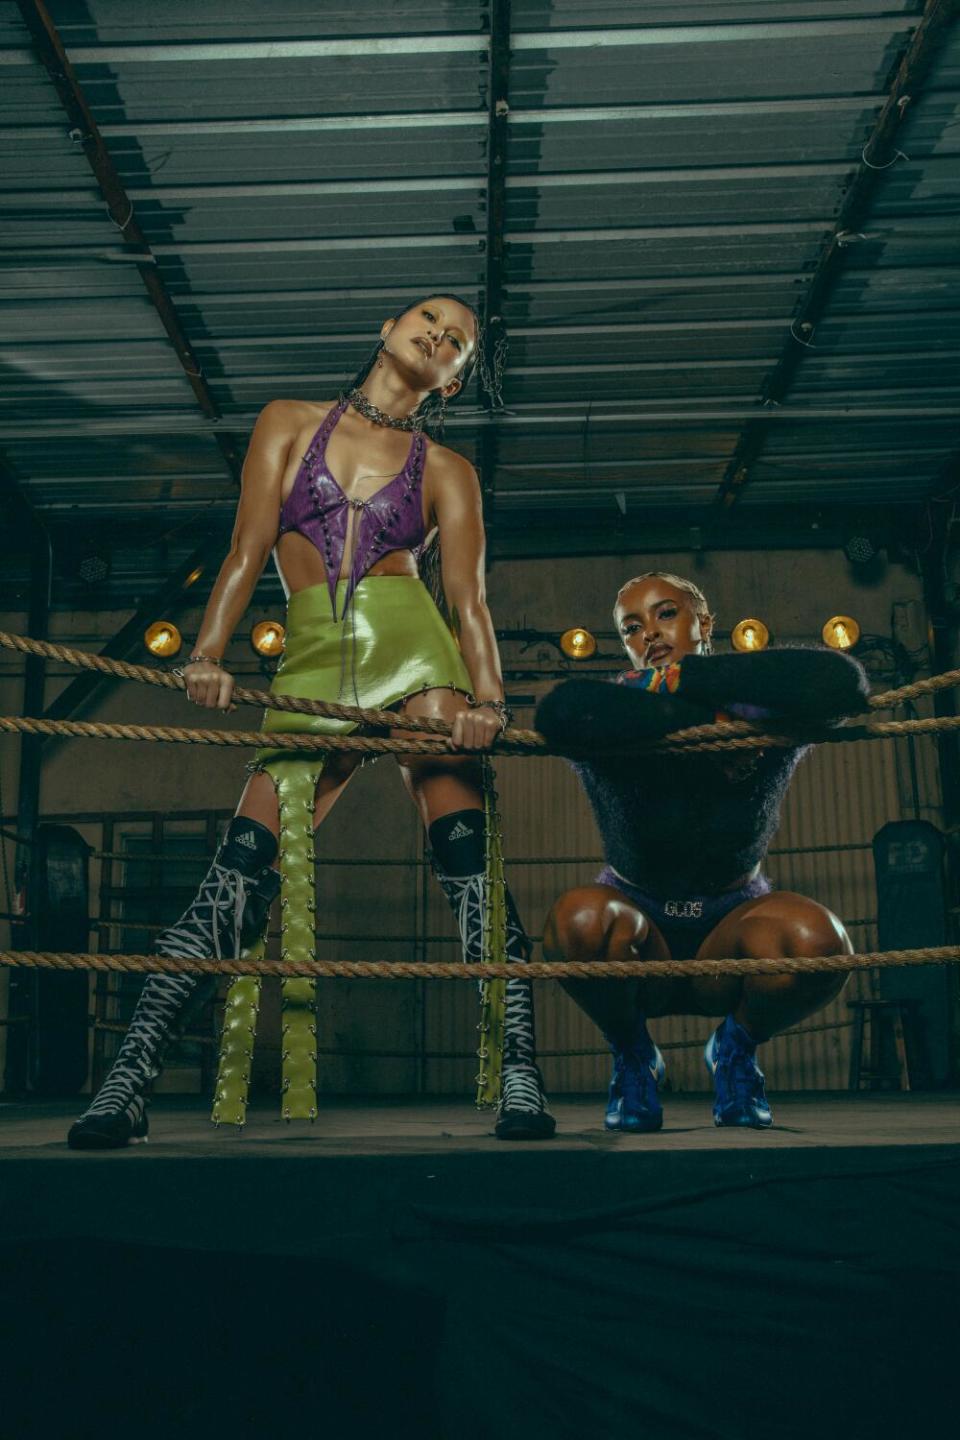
537 649 869 899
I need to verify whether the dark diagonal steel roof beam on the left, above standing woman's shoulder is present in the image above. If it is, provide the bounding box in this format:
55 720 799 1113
17 0 240 484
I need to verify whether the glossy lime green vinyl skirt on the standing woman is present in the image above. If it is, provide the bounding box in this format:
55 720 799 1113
255 575 471 769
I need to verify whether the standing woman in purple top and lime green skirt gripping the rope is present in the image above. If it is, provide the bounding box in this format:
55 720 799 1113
68 295 556 1149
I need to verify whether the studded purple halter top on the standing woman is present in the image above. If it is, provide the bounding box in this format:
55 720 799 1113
278 400 426 619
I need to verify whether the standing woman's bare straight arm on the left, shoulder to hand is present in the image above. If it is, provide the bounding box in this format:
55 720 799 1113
184 400 301 710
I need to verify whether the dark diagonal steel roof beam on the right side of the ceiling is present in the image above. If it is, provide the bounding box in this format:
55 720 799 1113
715 0 957 508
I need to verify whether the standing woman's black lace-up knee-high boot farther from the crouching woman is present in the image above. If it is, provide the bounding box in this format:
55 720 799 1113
66 816 281 1151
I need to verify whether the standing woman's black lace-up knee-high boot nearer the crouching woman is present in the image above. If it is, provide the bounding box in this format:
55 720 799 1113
429 809 557 1140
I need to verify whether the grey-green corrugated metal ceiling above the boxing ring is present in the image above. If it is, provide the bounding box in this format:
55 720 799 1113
0 0 960 601
